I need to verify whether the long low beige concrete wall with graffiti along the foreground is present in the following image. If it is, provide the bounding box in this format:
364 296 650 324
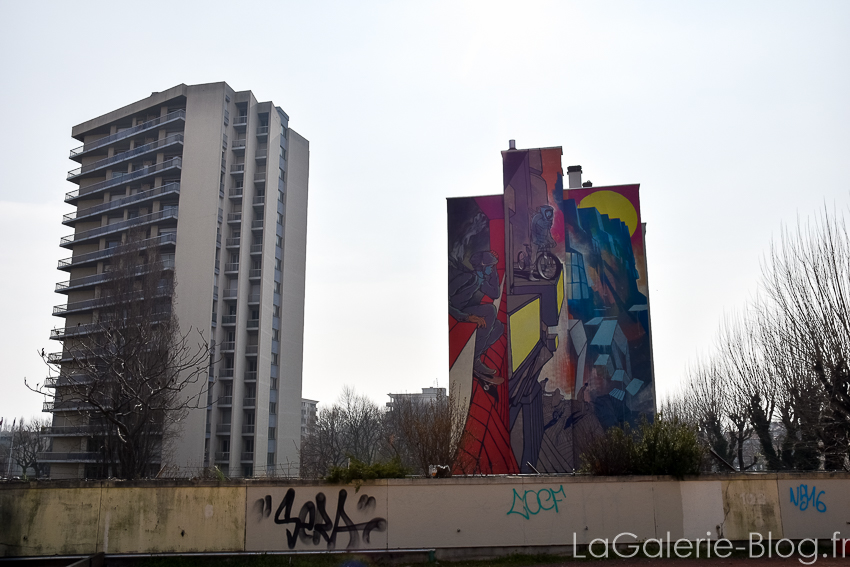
0 473 850 556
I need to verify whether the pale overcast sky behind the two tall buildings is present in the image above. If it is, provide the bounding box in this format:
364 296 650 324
0 0 850 419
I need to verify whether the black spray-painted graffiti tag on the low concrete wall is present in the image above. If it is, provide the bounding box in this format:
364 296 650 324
256 488 387 549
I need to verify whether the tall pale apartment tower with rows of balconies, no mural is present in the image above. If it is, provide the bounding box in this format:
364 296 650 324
43 82 309 478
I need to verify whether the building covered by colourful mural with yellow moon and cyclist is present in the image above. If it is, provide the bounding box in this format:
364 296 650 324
448 144 655 474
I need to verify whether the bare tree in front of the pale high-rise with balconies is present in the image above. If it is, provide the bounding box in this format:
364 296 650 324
30 238 210 478
